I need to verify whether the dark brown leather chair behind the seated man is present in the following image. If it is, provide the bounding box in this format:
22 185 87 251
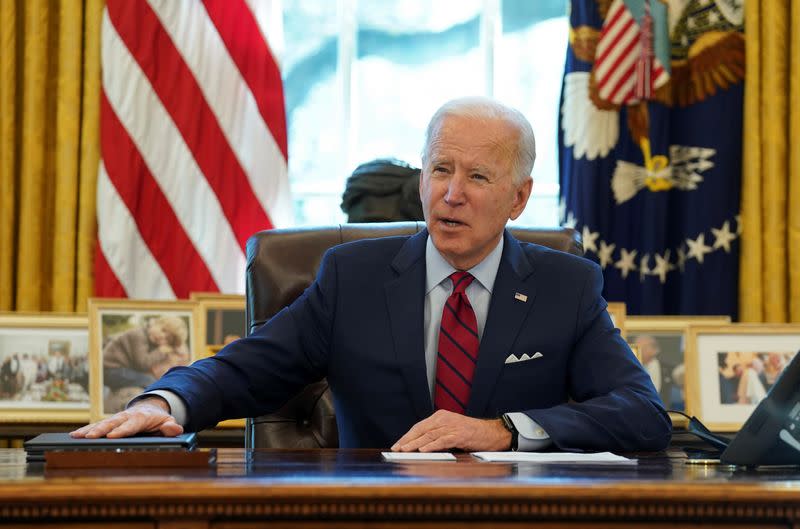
245 222 583 448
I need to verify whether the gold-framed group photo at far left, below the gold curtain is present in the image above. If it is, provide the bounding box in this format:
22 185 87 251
0 313 90 424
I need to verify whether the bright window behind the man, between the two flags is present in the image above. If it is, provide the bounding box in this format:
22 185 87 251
279 0 568 226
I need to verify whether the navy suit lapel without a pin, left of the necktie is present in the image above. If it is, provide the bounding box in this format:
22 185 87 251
384 230 433 420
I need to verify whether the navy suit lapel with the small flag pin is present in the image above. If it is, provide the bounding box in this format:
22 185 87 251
467 231 536 417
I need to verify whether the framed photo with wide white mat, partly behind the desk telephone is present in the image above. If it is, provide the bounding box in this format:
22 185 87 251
686 323 800 432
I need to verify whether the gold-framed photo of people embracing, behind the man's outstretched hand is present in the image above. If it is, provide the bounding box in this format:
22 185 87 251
89 298 201 421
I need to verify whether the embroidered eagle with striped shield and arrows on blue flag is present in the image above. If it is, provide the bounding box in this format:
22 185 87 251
562 0 744 203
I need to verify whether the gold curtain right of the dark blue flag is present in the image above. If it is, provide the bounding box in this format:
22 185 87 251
739 0 800 322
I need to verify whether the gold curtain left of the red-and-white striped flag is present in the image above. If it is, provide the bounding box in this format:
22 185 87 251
0 0 103 312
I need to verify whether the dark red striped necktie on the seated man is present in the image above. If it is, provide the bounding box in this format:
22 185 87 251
433 272 479 414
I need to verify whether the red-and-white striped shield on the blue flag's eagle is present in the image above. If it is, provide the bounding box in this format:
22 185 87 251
594 0 669 105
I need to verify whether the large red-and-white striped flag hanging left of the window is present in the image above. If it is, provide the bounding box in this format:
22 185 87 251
95 0 291 299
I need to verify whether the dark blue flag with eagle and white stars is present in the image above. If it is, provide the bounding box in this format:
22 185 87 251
559 0 744 318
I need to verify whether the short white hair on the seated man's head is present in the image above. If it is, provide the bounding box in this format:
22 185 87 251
422 97 536 184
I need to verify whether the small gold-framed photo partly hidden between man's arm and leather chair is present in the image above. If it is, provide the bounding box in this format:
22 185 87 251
197 296 247 358
